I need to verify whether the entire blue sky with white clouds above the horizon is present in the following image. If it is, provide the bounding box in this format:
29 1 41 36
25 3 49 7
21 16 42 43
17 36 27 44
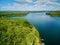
0 0 60 11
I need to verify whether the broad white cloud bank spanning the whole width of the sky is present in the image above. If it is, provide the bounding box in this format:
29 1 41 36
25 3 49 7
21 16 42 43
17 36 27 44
0 0 60 11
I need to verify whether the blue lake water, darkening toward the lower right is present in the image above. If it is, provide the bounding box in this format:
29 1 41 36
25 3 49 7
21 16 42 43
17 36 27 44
10 13 60 45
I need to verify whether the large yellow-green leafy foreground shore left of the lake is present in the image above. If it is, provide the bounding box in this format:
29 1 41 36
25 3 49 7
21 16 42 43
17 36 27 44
0 18 39 45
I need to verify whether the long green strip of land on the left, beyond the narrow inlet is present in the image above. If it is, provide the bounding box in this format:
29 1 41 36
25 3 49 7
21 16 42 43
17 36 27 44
0 11 29 17
